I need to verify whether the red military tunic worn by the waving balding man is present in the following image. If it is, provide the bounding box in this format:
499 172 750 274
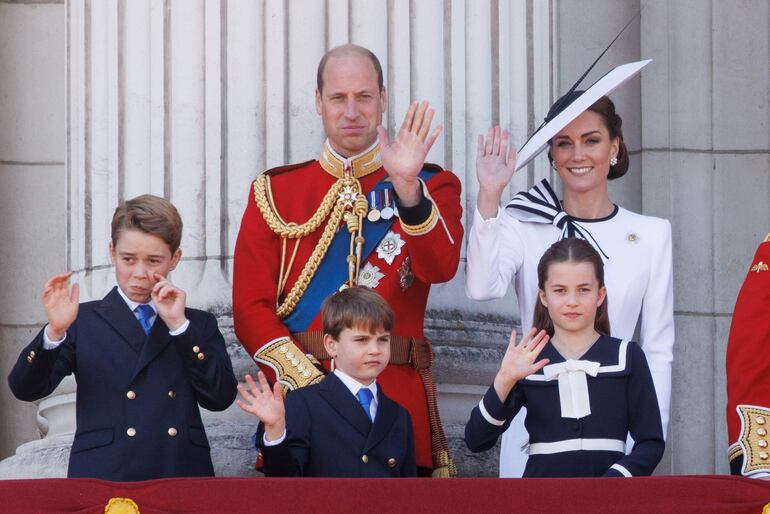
233 143 463 468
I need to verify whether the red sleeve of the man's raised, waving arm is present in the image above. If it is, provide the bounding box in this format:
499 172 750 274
401 171 463 284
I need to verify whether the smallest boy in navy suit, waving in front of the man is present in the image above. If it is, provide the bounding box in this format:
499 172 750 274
238 287 416 478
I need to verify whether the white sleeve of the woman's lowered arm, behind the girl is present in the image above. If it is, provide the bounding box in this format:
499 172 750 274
639 220 674 437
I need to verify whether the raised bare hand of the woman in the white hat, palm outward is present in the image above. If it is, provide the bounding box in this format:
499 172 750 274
476 126 516 219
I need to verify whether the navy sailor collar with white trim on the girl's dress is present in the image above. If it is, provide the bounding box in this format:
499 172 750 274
524 335 632 386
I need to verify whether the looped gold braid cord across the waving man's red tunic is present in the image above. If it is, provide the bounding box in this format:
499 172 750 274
254 170 369 319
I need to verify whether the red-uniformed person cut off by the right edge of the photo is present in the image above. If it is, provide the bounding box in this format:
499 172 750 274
727 234 770 479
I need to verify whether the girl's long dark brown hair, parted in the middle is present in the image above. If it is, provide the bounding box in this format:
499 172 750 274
532 237 610 337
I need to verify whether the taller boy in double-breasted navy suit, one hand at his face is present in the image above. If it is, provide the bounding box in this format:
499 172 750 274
8 195 237 481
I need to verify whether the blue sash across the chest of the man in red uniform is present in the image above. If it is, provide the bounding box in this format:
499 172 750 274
283 169 436 333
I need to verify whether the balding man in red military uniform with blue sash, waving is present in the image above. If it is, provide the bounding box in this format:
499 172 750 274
233 45 463 476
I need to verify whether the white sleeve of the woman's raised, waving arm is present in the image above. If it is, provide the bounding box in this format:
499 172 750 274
465 208 524 300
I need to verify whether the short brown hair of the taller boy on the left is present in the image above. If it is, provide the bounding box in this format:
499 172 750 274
111 195 182 254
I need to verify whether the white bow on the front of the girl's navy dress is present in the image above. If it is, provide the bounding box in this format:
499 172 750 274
543 359 600 419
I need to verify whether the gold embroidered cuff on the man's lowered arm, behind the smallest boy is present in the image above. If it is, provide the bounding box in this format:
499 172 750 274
254 337 324 391
